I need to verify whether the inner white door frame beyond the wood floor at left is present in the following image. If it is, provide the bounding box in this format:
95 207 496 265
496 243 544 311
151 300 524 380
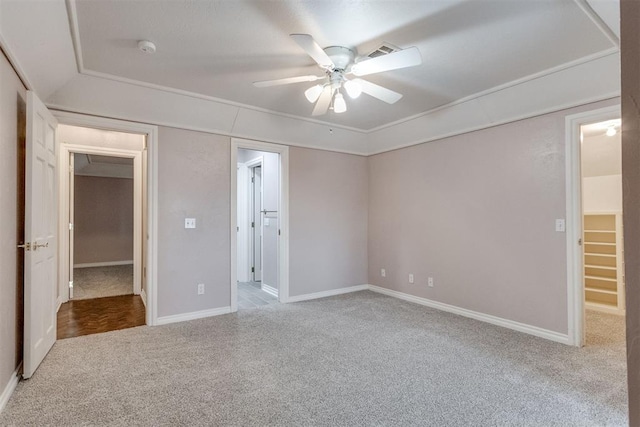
58 143 146 302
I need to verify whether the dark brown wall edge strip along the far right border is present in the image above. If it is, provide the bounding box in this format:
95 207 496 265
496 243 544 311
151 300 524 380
620 0 640 426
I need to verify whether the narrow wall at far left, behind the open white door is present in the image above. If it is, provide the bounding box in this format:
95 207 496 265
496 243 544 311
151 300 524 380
0 52 26 400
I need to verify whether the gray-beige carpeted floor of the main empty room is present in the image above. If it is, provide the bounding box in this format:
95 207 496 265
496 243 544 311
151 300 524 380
0 291 627 426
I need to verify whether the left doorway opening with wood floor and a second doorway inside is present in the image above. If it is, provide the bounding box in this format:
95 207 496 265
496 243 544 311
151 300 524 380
58 125 147 338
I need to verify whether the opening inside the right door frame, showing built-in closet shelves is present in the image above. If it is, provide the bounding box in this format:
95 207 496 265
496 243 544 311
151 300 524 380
580 118 625 346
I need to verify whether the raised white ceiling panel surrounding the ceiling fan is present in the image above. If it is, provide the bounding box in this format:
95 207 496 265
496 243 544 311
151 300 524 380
69 0 618 130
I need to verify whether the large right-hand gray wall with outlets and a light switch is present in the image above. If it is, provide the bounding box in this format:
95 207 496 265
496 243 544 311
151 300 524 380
369 102 610 333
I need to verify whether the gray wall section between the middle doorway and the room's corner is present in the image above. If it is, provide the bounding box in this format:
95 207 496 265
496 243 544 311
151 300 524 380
289 147 369 296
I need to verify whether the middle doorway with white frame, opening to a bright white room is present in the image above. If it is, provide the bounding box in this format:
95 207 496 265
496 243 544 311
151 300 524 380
231 139 289 311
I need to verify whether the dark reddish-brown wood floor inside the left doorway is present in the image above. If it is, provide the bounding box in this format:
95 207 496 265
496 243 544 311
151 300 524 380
58 295 145 339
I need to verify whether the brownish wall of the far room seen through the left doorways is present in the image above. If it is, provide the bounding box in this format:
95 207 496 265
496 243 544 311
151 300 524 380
73 175 133 265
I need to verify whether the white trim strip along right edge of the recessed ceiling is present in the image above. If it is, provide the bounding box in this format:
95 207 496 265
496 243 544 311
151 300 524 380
365 47 620 133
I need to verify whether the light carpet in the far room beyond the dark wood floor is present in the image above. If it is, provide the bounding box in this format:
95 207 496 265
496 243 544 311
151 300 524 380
73 265 133 300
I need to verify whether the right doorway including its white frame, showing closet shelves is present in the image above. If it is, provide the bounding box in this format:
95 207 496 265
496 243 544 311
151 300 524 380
566 106 625 351
